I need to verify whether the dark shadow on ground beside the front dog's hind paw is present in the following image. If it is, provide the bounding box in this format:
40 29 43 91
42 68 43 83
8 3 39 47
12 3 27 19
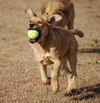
65 84 100 101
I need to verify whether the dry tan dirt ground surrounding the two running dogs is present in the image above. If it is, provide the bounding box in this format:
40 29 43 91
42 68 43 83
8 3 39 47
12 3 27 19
0 0 100 103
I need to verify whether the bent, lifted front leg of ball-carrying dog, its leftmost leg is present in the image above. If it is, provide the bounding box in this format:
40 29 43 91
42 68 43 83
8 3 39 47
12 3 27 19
38 63 50 85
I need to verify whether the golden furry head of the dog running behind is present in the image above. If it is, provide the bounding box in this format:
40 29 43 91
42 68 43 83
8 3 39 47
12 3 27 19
41 1 64 25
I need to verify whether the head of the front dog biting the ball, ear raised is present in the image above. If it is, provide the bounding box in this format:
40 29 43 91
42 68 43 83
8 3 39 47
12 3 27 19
25 9 49 43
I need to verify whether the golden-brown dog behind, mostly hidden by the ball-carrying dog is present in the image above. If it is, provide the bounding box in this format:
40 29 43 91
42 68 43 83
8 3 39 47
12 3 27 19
41 0 75 29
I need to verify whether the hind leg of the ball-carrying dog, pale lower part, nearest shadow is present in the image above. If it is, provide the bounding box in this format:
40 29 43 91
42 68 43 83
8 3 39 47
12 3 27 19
66 45 78 93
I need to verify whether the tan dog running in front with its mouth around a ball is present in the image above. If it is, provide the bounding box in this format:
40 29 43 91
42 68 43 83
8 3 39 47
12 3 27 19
25 9 83 93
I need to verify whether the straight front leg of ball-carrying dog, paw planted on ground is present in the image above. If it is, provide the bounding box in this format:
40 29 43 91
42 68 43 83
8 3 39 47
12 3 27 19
51 60 61 93
